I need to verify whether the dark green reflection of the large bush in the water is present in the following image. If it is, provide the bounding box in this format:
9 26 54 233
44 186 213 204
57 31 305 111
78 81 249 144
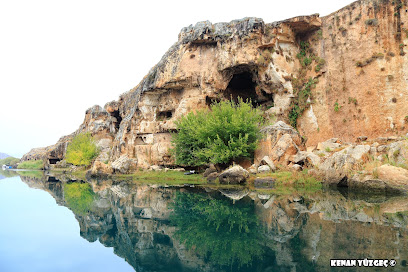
170 193 263 267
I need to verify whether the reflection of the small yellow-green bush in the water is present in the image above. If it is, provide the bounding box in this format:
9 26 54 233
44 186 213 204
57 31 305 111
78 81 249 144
64 182 95 215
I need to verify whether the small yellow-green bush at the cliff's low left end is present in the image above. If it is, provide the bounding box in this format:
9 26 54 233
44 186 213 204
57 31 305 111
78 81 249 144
65 133 99 166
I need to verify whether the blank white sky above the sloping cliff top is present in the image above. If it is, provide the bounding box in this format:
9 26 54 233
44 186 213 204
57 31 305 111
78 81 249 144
0 0 354 157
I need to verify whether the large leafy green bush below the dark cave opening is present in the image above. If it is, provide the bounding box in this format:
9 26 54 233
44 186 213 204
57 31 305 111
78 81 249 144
172 99 263 166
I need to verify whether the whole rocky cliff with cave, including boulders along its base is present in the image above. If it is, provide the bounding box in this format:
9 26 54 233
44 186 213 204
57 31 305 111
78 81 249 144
22 0 408 196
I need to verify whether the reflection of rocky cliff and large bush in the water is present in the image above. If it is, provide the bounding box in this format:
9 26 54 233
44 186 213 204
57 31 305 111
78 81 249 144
18 177 408 271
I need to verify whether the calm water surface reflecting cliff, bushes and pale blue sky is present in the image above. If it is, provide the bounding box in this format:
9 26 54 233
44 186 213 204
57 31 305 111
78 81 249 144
0 173 408 271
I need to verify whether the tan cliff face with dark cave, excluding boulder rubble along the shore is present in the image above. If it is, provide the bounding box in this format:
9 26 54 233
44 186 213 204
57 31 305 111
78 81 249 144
23 0 408 168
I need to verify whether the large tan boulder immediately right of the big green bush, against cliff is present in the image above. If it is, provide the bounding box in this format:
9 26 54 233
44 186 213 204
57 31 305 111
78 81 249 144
255 121 304 165
